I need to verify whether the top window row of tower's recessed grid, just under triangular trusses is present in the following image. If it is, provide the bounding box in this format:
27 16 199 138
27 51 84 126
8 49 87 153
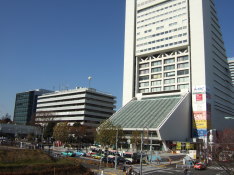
139 55 189 68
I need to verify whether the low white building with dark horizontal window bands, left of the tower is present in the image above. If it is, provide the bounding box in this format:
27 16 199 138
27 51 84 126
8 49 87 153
36 88 116 127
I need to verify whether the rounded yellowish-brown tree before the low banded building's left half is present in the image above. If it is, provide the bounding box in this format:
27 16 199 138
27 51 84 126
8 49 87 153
53 122 69 143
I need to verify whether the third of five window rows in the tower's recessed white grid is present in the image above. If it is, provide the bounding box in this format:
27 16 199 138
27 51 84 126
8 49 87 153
139 69 189 81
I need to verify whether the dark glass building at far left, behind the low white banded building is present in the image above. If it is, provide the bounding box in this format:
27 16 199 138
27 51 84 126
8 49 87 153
13 89 52 125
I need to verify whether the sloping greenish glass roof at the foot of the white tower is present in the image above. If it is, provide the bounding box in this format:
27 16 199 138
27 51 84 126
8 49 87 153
110 96 182 129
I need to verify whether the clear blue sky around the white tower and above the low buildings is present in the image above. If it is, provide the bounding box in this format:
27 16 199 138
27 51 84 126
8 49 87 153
0 0 234 116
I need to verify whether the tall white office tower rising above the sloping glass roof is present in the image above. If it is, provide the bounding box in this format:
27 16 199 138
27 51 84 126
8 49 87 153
123 0 234 137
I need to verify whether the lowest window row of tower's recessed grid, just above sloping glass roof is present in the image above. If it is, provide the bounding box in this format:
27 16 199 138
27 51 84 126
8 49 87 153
139 84 189 93
